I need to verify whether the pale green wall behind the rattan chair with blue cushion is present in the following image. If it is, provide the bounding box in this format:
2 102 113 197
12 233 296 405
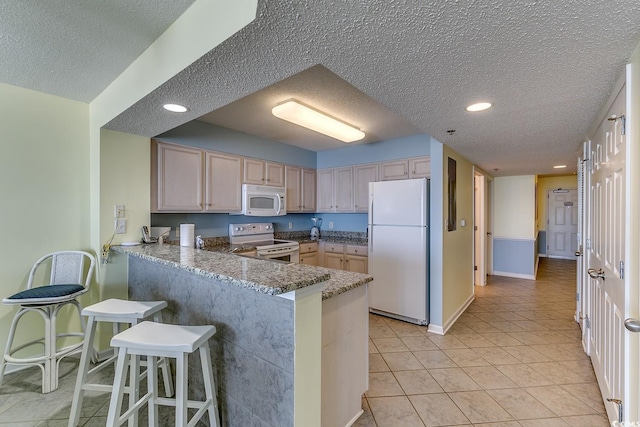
0 83 91 360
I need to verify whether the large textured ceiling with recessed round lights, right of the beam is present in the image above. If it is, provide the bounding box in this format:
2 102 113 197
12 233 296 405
5 0 640 176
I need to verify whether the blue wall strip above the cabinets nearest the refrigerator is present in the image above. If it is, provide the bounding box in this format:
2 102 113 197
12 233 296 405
317 134 431 169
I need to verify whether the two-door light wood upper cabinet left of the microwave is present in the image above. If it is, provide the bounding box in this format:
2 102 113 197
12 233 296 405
151 141 242 212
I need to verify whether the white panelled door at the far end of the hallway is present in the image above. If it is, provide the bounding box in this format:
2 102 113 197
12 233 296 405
547 188 578 259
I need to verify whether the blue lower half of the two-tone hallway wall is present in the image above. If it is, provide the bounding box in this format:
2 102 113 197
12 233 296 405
493 238 538 276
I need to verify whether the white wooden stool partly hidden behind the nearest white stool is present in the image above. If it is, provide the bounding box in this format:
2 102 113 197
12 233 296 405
68 298 173 427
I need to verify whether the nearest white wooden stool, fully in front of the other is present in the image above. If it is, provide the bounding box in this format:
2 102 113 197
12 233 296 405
107 322 220 427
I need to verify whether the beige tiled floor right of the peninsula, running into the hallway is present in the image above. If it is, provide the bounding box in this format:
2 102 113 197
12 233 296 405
354 258 609 427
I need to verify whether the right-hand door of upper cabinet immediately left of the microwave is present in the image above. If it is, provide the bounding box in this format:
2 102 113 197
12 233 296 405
205 152 242 213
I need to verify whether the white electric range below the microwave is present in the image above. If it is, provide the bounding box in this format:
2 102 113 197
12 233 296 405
229 222 300 264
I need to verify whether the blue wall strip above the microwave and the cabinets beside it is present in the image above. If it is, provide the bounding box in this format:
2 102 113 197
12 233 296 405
156 121 316 169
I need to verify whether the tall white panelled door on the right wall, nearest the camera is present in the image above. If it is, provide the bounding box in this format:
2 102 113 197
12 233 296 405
587 81 637 420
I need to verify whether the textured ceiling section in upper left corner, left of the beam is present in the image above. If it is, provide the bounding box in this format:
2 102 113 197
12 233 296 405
0 0 195 102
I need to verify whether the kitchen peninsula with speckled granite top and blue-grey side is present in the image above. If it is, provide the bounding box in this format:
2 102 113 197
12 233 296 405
113 245 372 426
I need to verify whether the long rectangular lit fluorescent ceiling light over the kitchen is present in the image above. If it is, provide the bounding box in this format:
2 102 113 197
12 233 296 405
271 99 365 143
